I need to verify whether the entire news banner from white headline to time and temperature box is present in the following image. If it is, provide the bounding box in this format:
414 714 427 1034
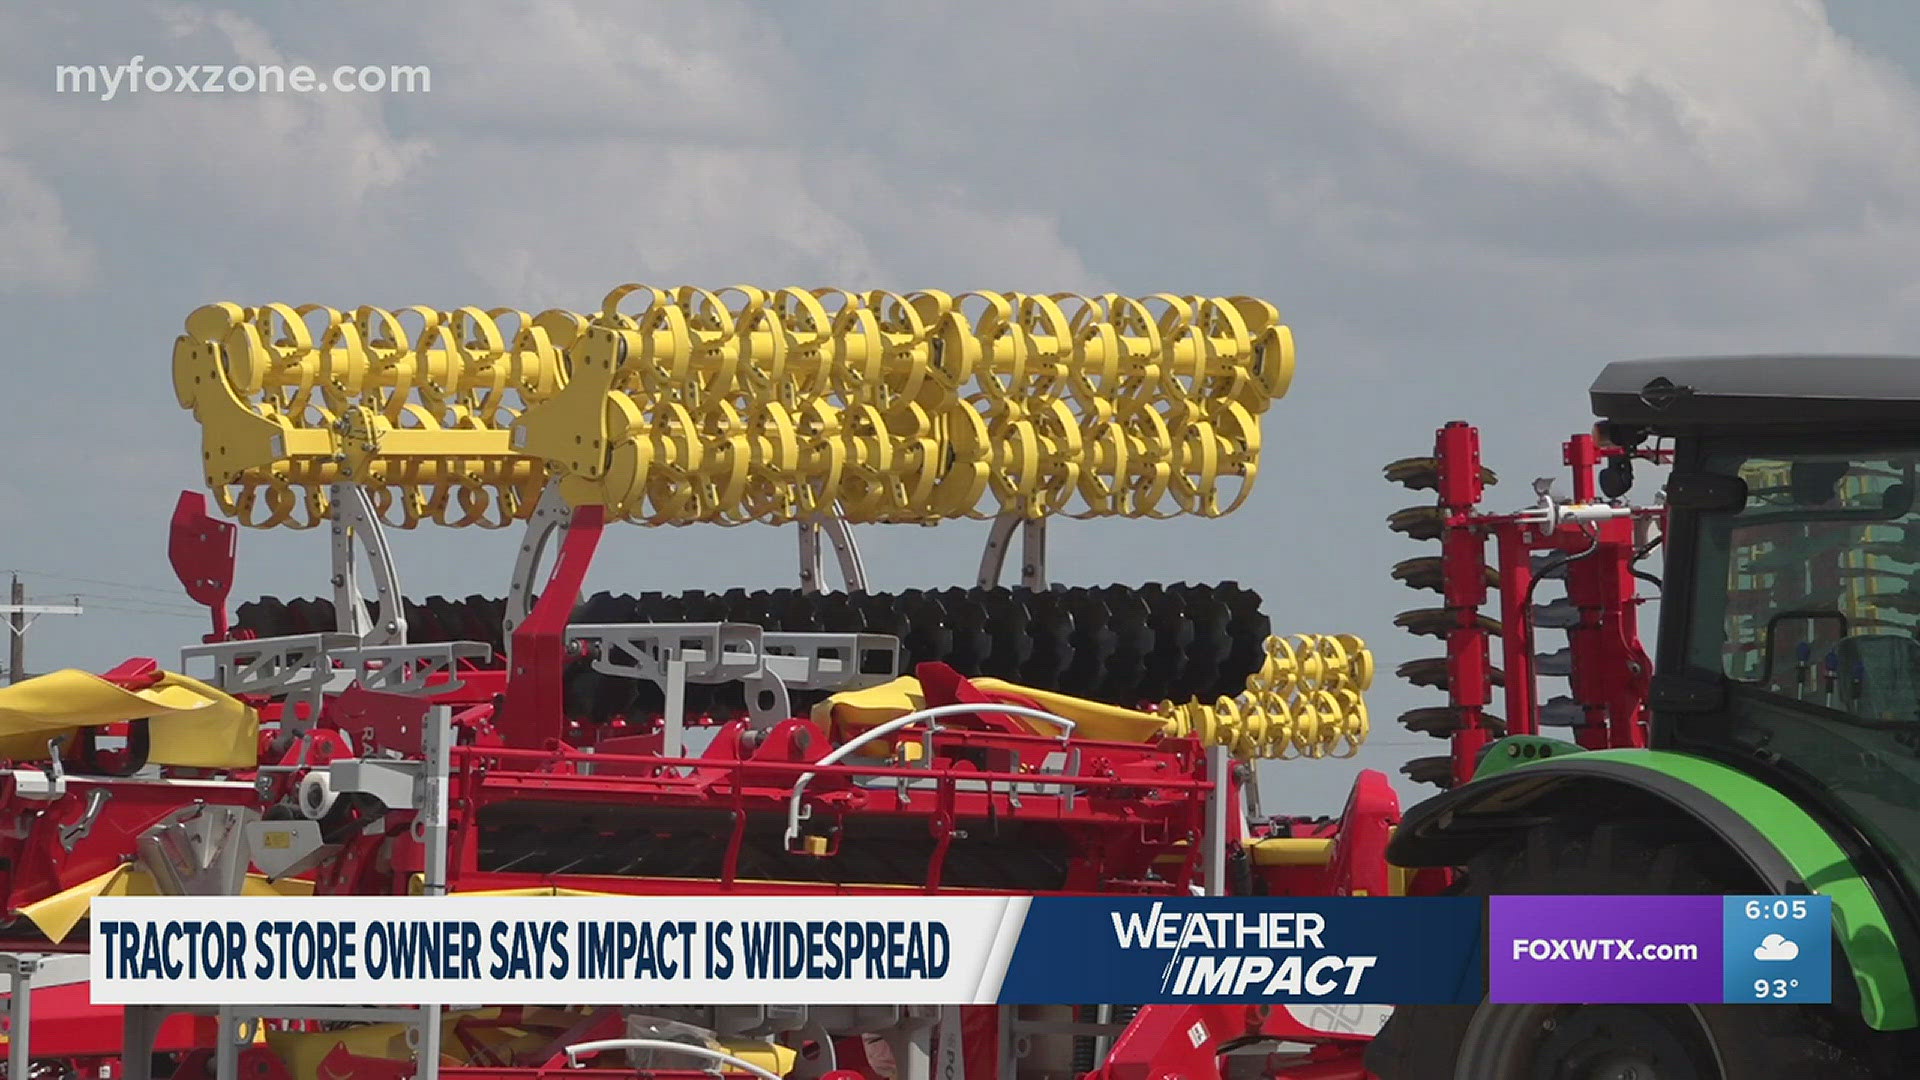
88 896 1832 1009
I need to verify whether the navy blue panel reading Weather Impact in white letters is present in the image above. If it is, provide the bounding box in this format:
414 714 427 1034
998 897 1486 1005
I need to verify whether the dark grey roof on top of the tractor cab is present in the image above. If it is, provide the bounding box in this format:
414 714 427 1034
1592 354 1920 434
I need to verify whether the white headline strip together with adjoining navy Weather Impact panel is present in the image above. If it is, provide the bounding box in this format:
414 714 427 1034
90 896 1484 1005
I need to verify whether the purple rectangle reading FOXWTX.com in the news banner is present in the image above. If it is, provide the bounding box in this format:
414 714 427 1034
1488 896 1726 1005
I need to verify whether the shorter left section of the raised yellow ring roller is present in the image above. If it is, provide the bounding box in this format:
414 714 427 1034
173 304 563 528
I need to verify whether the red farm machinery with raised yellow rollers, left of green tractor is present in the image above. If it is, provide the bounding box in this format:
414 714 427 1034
0 286 1397 1080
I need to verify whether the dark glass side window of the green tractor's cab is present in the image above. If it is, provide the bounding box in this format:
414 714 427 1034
1686 450 1920 890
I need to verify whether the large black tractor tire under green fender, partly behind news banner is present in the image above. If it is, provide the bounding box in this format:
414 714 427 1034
1367 824 1884 1080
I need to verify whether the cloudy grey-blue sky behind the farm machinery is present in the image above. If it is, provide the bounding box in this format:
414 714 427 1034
0 0 1920 815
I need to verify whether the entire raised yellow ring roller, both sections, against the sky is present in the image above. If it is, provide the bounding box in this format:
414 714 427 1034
173 284 1294 528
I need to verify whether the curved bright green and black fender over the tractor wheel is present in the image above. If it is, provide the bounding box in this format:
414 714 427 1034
1386 736 1920 1032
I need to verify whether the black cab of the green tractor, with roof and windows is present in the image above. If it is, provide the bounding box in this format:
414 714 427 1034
1594 357 1920 907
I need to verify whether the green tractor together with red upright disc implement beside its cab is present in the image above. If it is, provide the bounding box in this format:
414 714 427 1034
1367 356 1920 1080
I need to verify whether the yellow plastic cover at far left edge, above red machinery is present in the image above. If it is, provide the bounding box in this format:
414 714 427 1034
0 669 259 769
